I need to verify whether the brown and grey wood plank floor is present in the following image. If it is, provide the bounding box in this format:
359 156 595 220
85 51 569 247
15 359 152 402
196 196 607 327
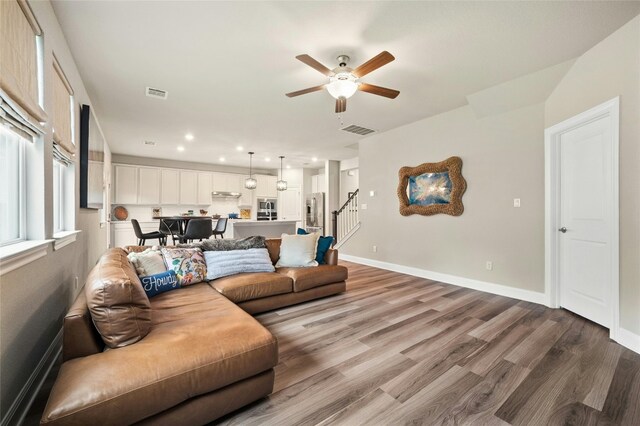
26 262 640 426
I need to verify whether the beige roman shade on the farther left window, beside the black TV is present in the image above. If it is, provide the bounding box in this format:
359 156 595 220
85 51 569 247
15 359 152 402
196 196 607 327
51 55 75 154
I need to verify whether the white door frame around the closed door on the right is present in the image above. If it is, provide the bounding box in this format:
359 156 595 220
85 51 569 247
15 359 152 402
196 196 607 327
544 96 620 340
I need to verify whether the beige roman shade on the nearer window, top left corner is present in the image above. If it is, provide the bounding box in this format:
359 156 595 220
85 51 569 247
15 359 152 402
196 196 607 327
0 0 47 123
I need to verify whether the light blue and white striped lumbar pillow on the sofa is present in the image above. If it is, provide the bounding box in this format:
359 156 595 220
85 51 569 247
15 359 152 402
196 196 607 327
204 249 275 281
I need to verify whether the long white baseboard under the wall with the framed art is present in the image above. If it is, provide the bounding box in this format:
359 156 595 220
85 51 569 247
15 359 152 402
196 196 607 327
340 253 548 306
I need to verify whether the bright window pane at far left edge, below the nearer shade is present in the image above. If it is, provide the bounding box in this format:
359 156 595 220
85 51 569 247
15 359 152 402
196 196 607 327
0 125 27 246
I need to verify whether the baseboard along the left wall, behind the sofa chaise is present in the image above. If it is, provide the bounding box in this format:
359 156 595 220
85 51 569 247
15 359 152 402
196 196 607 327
0 329 62 426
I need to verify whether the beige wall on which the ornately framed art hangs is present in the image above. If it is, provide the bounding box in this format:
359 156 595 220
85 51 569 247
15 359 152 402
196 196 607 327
340 104 544 293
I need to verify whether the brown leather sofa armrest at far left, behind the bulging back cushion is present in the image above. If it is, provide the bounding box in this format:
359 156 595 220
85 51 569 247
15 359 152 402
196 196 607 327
62 291 104 362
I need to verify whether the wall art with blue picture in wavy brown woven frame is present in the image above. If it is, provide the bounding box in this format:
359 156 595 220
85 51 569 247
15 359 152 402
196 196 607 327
398 157 467 216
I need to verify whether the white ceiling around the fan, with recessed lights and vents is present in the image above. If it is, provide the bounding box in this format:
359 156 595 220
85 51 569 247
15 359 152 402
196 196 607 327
53 0 640 167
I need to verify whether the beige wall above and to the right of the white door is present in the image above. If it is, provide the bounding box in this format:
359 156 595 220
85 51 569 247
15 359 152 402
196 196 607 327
545 17 640 335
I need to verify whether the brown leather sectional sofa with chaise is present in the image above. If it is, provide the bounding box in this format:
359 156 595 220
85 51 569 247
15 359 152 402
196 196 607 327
41 239 347 425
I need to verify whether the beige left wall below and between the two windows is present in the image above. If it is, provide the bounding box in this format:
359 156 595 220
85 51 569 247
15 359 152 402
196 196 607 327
0 1 110 421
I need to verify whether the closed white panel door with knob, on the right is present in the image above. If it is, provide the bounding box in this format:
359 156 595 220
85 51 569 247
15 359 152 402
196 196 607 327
558 113 614 328
